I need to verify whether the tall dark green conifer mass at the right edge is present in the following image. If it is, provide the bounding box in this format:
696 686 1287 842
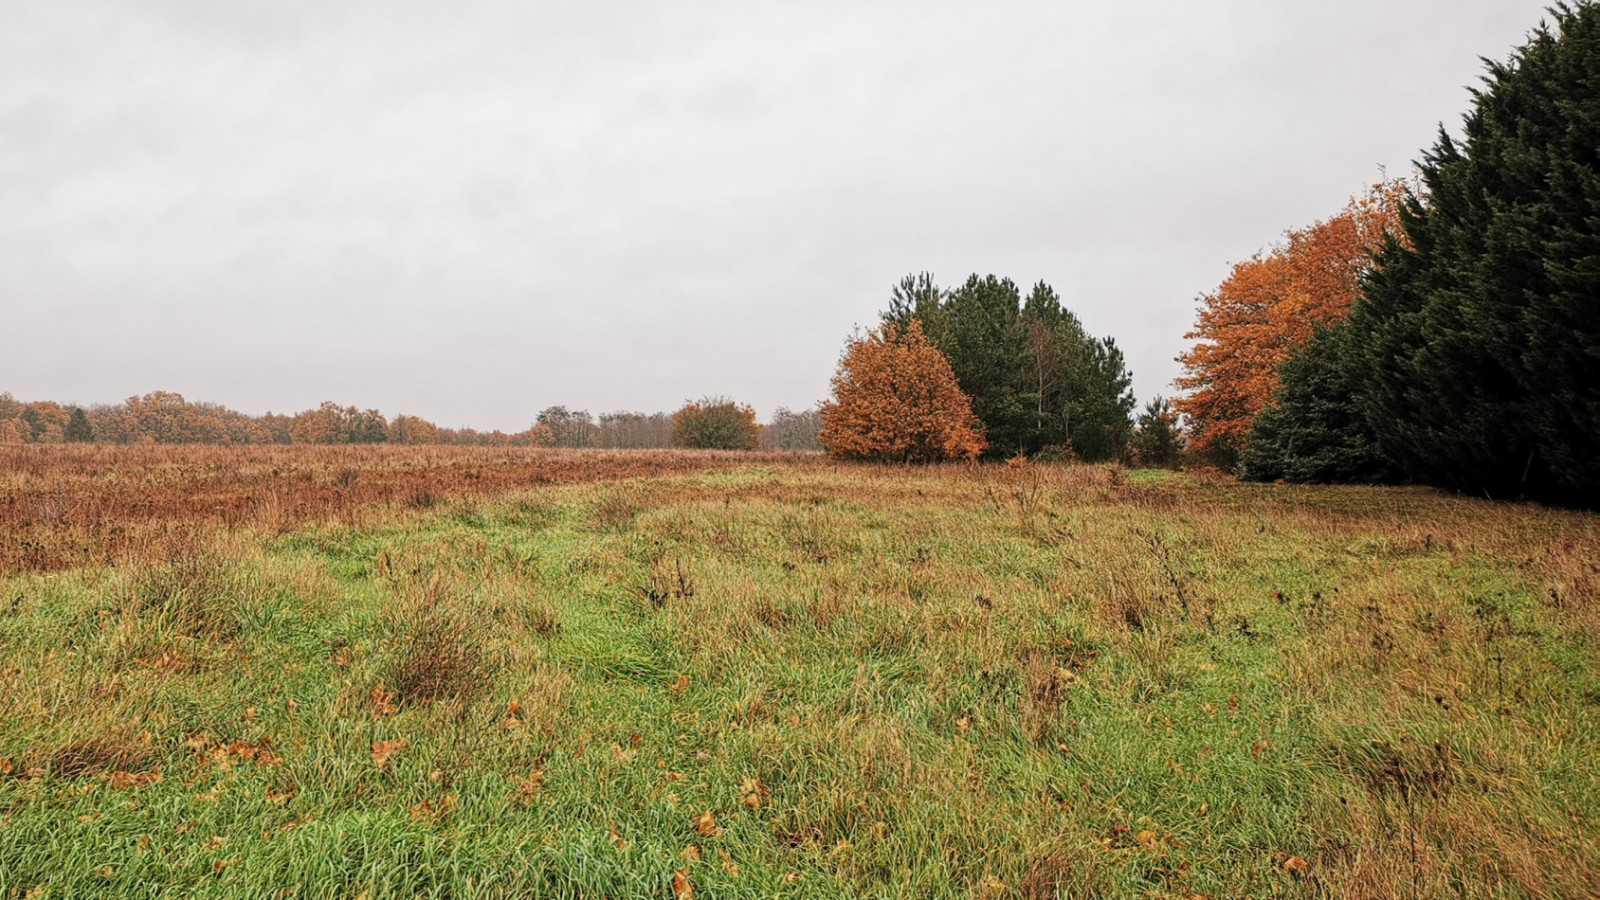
1256 3 1600 506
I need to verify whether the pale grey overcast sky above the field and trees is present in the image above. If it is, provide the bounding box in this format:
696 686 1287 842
0 0 1546 431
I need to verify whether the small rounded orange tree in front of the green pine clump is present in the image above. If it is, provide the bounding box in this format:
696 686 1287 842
818 319 989 463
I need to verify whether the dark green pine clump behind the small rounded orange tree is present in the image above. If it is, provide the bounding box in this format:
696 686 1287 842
882 272 1133 461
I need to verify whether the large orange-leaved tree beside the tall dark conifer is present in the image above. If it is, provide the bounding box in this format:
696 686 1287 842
1173 181 1405 466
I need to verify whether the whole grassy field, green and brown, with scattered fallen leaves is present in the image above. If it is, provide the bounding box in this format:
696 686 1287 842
0 447 1600 900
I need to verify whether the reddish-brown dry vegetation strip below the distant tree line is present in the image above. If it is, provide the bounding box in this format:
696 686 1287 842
0 445 819 573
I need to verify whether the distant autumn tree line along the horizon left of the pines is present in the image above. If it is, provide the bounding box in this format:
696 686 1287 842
0 391 821 450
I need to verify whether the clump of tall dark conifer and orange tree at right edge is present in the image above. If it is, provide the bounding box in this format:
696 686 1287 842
1178 2 1600 508
